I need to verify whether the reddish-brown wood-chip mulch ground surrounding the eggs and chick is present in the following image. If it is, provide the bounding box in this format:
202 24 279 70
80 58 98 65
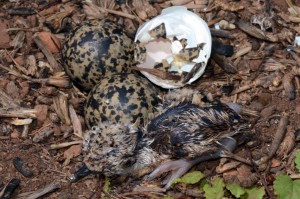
0 0 300 198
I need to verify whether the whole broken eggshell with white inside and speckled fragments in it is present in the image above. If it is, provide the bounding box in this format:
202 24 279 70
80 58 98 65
133 6 212 88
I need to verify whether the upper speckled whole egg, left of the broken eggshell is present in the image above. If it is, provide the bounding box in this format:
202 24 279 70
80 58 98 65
62 20 133 91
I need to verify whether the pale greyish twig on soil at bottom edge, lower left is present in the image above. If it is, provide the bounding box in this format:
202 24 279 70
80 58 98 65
17 182 61 199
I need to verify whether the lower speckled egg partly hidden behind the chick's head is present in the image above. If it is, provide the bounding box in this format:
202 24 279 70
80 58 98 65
84 74 158 128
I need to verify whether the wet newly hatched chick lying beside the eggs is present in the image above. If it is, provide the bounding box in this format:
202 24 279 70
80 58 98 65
73 89 251 188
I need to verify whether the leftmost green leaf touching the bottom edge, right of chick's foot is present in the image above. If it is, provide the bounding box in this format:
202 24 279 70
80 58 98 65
203 178 225 199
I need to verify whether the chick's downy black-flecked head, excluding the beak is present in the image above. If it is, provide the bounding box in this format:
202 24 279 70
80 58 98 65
83 123 140 176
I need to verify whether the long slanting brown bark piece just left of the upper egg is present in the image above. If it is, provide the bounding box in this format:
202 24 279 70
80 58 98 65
33 34 63 72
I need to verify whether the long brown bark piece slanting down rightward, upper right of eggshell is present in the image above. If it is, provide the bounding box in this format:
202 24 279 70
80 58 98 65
237 20 279 42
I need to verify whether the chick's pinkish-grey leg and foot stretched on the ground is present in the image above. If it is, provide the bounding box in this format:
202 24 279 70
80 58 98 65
147 137 237 189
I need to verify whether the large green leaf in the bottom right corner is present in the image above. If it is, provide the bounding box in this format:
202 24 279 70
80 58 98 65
273 175 300 199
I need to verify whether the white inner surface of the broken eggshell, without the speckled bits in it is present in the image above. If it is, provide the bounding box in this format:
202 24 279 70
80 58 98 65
135 6 212 88
